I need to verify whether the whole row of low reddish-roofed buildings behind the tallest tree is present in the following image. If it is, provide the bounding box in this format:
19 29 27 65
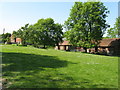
55 38 120 55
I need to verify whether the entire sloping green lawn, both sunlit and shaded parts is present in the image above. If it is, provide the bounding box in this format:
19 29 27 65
0 45 118 88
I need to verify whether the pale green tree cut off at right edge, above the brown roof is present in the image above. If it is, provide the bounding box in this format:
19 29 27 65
107 16 120 38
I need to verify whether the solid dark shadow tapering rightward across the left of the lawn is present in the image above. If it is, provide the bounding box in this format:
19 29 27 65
2 53 68 72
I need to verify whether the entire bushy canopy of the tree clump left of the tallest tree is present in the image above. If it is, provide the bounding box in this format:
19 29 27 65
13 18 63 47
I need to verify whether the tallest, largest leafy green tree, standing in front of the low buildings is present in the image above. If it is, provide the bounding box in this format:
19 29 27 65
64 2 109 52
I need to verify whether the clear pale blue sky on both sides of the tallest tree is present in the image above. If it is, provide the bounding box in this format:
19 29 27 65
0 0 118 34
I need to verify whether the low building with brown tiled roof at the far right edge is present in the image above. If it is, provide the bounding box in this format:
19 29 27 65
98 38 120 55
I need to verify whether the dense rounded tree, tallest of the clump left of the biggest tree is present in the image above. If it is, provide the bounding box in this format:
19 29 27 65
29 18 63 48
